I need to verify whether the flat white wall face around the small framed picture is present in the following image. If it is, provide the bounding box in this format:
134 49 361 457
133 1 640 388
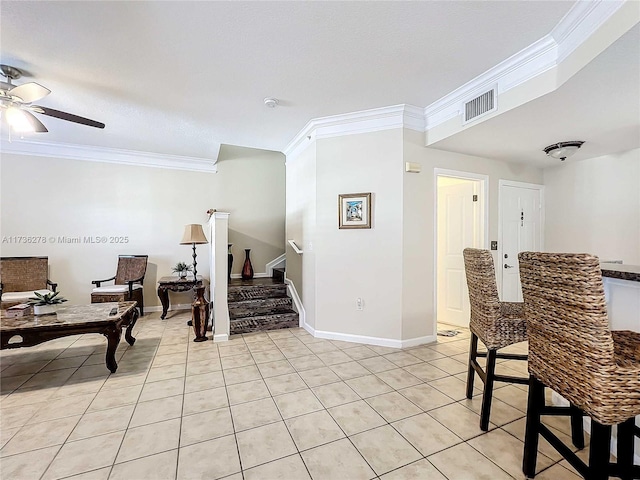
315 129 403 339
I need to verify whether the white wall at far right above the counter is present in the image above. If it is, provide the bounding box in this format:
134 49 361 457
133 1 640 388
544 149 640 265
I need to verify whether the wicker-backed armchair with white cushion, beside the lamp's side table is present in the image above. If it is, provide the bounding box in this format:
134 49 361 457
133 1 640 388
91 255 149 316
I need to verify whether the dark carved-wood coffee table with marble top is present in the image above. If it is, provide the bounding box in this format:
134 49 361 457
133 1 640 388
0 302 138 373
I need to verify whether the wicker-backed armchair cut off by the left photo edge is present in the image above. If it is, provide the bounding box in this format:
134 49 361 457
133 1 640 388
0 257 58 308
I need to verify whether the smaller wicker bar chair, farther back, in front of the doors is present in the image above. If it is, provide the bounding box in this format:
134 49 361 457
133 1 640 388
462 248 528 431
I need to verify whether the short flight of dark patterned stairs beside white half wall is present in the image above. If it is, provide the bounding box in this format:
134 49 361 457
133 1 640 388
227 278 298 335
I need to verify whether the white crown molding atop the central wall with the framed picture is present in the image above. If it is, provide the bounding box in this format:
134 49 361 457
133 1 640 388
283 104 425 159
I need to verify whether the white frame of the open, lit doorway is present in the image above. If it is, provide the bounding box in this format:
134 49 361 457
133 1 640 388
433 168 489 338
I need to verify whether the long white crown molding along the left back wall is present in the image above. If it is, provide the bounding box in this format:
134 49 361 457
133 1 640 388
1 140 220 173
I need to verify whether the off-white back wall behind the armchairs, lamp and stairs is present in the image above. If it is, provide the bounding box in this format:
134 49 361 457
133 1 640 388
0 146 284 306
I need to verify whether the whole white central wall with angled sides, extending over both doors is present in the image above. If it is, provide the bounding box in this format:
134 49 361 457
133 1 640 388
287 128 542 345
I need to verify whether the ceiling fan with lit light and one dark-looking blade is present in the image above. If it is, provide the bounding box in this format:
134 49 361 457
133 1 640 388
0 65 104 133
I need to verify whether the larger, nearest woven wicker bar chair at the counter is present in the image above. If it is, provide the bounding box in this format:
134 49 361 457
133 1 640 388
518 252 640 480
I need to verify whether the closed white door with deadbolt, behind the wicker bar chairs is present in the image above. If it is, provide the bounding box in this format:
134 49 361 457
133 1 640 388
496 182 543 302
